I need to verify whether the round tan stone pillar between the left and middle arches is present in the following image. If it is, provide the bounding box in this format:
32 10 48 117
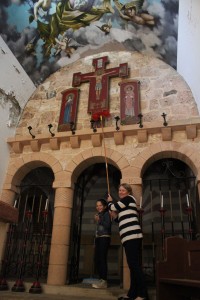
47 187 73 285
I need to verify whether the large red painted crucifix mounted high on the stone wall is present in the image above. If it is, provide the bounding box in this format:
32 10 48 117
72 56 128 114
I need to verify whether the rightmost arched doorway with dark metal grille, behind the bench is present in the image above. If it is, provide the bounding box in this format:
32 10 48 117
143 158 199 283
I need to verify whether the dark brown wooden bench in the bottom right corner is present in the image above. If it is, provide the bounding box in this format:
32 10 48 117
156 237 200 300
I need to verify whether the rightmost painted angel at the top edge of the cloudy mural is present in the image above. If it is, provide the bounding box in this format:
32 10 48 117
113 0 155 25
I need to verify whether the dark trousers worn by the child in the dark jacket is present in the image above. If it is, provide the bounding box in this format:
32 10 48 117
95 237 110 280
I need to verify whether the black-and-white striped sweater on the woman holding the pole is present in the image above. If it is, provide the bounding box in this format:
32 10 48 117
108 195 143 244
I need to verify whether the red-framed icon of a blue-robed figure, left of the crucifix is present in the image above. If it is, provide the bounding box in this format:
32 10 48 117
58 88 79 131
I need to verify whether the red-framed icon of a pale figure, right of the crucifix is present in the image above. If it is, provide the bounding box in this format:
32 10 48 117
119 80 140 125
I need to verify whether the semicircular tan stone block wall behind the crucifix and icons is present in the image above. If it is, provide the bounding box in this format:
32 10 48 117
16 51 199 135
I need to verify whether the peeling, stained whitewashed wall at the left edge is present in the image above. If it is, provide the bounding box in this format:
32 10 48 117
0 36 35 190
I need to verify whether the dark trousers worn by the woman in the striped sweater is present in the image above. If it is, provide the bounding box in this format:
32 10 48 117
123 239 147 299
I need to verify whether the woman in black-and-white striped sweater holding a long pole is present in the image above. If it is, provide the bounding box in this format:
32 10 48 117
107 183 147 300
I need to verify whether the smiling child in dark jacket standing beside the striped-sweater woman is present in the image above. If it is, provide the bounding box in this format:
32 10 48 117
92 199 111 289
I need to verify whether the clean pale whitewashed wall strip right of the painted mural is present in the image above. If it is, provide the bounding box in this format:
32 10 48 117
177 0 200 111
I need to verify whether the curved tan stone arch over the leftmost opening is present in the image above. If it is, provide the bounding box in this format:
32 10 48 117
3 153 64 190
